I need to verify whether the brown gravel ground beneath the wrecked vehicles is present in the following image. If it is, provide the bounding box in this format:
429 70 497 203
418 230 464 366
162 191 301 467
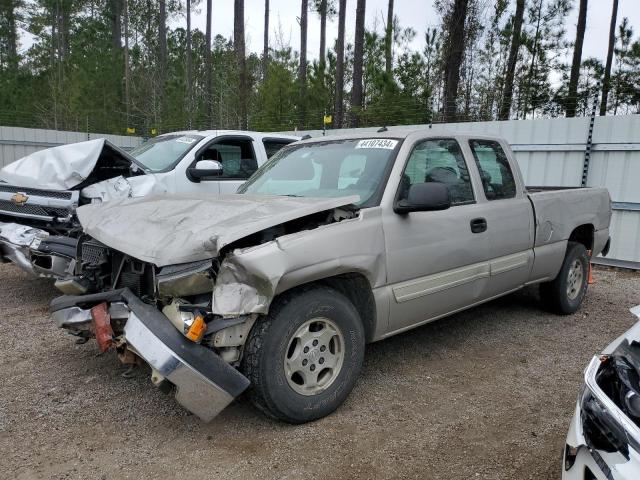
0 265 640 480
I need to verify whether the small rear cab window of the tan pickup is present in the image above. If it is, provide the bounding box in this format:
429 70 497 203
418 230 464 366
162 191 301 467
469 140 516 200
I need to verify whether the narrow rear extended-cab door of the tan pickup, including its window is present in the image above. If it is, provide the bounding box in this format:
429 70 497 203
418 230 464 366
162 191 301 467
465 137 534 298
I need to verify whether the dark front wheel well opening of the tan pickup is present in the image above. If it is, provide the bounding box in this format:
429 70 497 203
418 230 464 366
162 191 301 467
283 273 376 342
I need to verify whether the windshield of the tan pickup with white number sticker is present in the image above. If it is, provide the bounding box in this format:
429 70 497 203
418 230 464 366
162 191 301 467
238 138 400 206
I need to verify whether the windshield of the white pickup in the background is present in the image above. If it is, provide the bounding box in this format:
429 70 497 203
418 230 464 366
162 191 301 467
129 135 204 172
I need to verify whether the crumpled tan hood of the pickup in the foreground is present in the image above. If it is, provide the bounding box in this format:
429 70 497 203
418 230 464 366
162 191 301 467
77 194 359 267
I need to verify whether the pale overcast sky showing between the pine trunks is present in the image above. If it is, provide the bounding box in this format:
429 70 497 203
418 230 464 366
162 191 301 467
182 0 640 63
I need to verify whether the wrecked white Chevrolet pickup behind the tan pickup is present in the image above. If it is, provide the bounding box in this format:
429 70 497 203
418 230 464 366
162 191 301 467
0 130 297 279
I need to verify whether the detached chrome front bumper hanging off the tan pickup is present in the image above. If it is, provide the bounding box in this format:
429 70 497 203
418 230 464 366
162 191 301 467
51 289 249 422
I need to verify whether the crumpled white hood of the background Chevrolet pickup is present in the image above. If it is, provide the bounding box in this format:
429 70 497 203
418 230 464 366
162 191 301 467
0 138 138 190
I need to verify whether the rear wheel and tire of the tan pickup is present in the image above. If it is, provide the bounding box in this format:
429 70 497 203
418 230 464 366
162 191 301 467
540 242 589 315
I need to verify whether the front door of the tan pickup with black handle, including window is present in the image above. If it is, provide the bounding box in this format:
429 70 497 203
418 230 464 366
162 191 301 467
383 138 489 332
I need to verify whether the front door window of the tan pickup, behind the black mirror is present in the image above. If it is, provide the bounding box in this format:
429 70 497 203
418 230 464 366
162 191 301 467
399 138 474 205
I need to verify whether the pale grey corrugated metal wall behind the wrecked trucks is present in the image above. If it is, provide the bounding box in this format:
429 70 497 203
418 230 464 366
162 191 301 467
0 115 640 267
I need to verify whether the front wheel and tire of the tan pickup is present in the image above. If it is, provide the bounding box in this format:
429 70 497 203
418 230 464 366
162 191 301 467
241 287 365 423
